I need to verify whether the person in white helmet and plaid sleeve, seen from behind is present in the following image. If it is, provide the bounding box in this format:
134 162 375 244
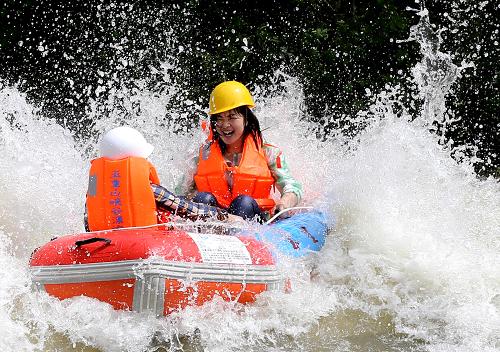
85 126 236 231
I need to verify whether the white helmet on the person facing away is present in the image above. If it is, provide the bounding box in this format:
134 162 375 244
99 126 154 160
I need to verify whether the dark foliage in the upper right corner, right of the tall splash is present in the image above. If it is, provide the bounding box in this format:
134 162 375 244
430 1 500 176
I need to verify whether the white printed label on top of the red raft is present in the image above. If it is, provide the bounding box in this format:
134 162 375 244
188 232 252 264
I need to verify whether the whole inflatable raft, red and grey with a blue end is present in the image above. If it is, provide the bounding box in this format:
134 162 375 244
30 212 327 315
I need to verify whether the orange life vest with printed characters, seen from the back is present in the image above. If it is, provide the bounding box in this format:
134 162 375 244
87 157 160 231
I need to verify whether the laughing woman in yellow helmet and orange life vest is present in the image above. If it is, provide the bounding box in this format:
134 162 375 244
178 81 302 219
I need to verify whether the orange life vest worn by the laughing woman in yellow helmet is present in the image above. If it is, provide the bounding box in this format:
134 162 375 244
194 136 275 211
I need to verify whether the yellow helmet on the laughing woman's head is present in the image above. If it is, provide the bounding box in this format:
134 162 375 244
208 81 255 115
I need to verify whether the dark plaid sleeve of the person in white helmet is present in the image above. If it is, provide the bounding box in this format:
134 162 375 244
151 183 228 221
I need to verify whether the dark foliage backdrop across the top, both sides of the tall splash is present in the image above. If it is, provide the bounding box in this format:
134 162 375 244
0 0 500 173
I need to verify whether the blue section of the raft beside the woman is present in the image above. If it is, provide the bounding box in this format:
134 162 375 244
243 211 328 258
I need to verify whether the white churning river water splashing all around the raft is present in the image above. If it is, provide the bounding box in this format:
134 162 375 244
0 4 500 352
